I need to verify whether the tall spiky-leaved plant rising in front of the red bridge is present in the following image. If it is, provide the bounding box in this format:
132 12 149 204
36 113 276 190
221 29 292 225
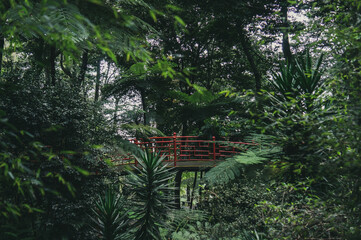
127 151 173 240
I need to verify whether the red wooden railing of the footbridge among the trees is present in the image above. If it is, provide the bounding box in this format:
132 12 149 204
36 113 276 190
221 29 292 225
113 133 254 167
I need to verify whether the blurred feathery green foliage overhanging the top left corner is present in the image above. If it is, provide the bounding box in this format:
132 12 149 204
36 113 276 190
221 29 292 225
2 0 156 60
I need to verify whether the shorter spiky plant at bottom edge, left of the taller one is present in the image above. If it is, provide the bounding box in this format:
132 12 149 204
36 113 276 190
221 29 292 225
91 187 127 240
